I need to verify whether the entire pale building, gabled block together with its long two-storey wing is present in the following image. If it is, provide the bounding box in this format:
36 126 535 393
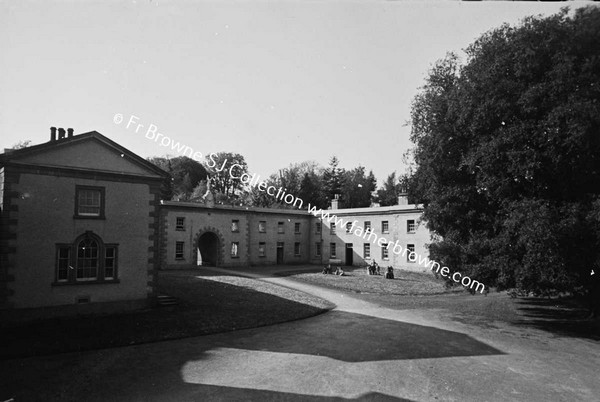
0 128 430 316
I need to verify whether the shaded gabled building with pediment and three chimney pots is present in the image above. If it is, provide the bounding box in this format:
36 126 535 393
0 128 167 315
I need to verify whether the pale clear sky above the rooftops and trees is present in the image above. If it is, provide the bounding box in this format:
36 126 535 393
0 0 591 184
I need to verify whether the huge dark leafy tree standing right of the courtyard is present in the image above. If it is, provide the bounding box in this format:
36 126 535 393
410 7 600 310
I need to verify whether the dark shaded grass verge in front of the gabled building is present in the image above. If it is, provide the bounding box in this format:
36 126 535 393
0 271 333 359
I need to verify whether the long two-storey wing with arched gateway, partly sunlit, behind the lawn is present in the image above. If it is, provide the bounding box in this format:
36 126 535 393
160 197 430 271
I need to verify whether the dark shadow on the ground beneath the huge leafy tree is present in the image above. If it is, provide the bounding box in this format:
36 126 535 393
516 297 600 341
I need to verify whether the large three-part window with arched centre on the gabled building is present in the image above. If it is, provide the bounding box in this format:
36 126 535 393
54 231 118 285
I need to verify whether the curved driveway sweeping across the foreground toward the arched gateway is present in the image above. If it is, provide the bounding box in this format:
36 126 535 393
0 269 600 401
